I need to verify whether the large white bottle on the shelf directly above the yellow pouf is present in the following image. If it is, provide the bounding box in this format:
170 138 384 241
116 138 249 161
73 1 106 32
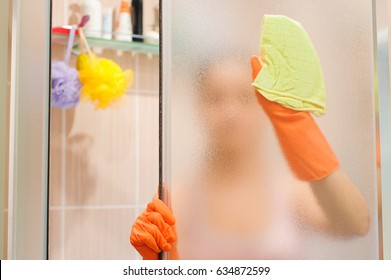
81 0 102 38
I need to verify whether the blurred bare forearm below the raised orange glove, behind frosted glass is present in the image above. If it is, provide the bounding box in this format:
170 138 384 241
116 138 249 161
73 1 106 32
296 169 370 237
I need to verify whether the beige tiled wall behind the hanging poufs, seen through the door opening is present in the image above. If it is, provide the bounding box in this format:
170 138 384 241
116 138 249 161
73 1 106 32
48 0 159 260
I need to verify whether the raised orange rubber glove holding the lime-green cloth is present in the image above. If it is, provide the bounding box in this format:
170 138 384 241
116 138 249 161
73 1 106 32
251 56 339 181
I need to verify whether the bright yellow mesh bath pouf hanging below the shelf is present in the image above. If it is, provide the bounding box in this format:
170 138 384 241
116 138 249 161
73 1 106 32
77 53 133 109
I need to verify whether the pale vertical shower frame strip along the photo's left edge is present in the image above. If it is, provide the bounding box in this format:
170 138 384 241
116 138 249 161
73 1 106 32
0 0 50 259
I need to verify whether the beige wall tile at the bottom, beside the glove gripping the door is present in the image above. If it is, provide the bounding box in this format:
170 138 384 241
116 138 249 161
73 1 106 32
65 209 136 260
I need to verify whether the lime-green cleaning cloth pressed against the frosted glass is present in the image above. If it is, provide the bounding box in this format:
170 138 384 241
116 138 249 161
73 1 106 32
252 15 326 116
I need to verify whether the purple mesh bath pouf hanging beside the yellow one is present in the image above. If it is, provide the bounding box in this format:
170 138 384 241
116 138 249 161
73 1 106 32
52 61 82 109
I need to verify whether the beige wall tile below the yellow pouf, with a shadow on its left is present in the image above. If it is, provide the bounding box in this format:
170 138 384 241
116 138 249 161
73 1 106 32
66 96 136 205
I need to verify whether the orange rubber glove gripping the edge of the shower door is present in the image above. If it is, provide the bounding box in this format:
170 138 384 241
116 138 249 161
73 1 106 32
130 198 176 260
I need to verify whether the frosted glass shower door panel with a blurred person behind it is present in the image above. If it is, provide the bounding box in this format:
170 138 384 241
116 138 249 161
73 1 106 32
162 0 378 259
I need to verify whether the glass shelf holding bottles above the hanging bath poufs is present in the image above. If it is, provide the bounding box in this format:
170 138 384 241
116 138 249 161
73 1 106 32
52 33 159 55
